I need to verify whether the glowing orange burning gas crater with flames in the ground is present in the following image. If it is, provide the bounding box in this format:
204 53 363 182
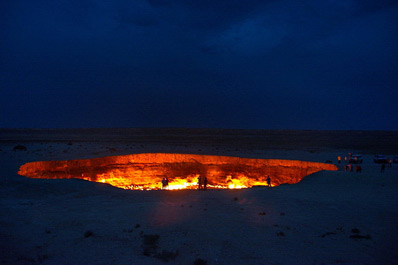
18 153 337 190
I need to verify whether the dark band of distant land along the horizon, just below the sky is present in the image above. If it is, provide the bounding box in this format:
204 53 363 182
0 128 398 155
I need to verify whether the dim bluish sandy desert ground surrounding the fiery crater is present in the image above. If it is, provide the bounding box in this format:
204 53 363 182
0 129 398 265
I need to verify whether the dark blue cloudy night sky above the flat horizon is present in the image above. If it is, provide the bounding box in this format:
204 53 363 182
0 0 398 130
